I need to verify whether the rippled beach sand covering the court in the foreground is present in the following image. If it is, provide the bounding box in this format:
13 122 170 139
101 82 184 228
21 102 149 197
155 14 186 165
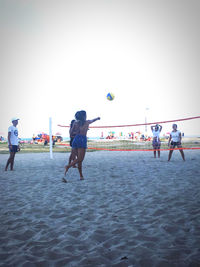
0 151 200 267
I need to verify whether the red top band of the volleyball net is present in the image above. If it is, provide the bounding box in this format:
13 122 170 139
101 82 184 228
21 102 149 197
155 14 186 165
58 116 200 128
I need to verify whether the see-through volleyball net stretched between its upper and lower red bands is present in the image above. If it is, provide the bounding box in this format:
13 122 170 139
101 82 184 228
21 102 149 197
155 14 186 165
58 116 200 151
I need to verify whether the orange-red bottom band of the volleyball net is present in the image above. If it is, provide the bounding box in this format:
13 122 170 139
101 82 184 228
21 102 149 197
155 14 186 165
56 144 200 151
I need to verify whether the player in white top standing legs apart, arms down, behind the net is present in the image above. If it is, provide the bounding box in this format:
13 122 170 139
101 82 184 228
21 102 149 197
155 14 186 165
168 124 185 161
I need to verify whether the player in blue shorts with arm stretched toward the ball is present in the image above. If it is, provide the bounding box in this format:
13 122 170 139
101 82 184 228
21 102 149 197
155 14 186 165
63 110 100 182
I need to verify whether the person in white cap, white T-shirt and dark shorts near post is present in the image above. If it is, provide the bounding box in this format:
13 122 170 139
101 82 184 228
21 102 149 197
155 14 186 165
5 118 20 171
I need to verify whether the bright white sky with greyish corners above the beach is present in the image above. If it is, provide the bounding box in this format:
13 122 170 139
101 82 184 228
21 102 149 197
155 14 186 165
0 0 200 137
